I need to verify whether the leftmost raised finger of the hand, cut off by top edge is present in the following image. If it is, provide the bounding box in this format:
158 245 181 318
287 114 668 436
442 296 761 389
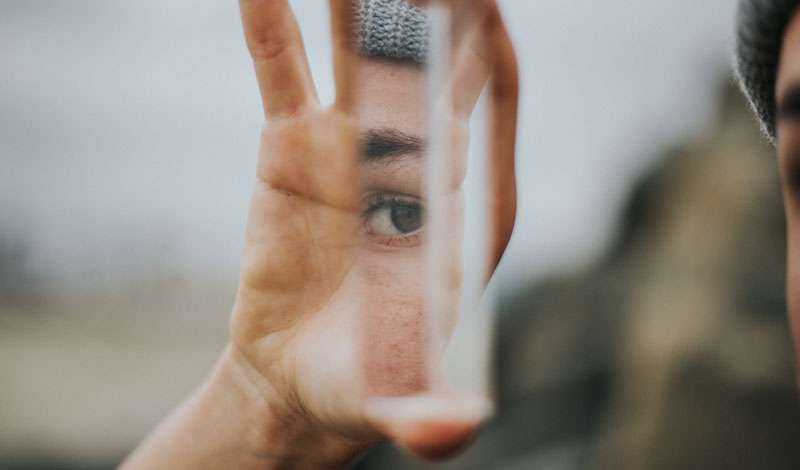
239 0 317 118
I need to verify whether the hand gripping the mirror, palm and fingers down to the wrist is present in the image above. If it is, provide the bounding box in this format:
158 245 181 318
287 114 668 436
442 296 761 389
232 0 517 456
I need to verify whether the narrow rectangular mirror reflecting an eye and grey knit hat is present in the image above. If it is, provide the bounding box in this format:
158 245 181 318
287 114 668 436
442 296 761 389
355 0 500 402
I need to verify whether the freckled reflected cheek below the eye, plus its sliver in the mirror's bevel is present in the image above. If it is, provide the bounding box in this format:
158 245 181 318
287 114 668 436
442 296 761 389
357 192 464 396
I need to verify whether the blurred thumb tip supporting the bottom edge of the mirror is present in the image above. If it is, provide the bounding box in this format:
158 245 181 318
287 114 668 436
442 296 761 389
365 393 492 460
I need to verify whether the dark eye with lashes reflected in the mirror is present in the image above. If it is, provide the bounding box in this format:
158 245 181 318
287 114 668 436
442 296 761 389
364 194 425 245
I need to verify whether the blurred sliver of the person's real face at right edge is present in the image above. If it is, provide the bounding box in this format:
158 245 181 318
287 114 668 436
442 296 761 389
775 10 800 364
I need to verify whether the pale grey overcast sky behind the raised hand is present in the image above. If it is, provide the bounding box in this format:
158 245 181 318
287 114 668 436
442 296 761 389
0 0 735 294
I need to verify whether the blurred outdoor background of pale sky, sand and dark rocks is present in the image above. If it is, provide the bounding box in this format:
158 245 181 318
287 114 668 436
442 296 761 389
0 0 800 469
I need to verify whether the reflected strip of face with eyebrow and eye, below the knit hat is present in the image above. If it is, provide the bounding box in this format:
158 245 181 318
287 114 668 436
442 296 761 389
355 59 476 396
